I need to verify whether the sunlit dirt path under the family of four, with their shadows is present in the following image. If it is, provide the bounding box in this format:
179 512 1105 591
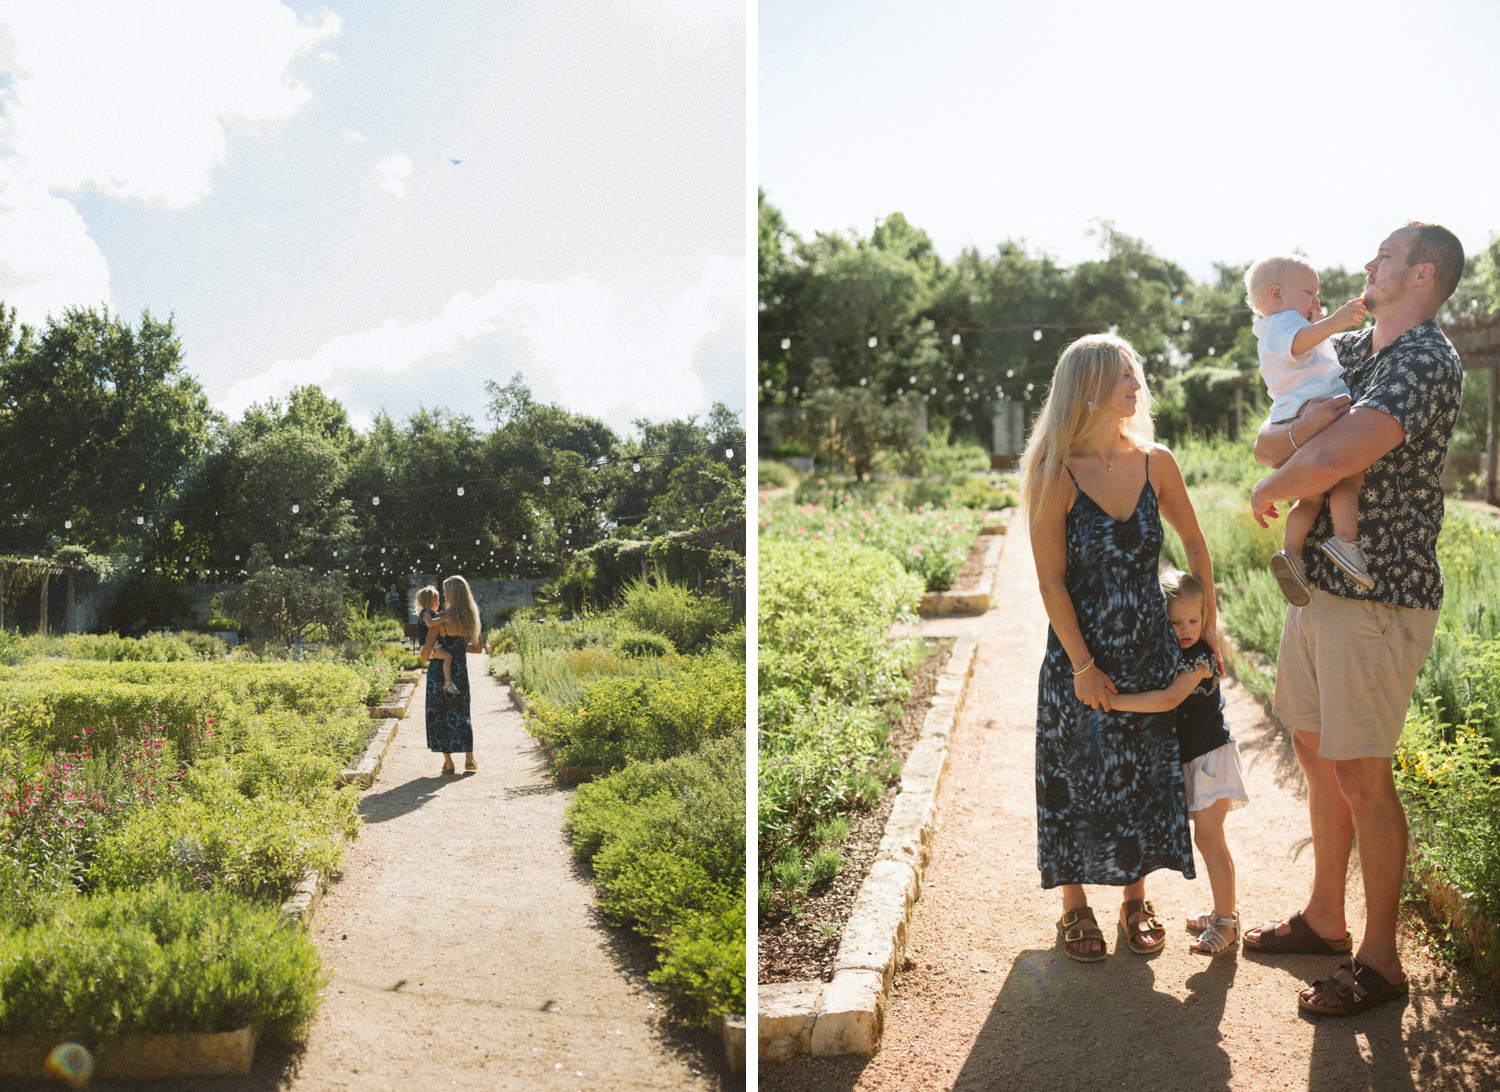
761 524 1500 1092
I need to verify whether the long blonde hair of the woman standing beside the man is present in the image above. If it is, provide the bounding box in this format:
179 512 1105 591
1022 333 1157 525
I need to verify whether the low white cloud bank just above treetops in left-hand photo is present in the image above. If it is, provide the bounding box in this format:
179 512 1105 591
218 258 744 431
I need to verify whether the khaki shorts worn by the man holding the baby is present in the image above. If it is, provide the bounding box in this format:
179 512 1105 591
1271 588 1437 761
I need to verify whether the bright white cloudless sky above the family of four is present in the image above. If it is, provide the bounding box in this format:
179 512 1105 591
758 0 1500 286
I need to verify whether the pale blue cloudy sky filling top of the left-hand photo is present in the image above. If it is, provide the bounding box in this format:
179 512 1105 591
0 0 746 429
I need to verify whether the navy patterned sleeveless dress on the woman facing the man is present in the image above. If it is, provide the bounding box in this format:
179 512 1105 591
1037 455 1194 888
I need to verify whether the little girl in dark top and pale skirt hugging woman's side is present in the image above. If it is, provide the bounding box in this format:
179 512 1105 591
1113 570 1250 956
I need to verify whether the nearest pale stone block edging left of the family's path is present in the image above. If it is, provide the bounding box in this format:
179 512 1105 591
758 630 978 1062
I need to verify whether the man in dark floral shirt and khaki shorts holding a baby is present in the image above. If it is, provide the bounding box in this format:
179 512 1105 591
1245 222 1464 1016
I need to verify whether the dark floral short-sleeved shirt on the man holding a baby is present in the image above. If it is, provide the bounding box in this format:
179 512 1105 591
1304 321 1464 611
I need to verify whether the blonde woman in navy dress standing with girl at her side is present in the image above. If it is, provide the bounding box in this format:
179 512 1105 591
1022 335 1218 963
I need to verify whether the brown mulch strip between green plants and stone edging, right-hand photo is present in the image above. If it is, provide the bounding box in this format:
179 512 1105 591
756 641 953 983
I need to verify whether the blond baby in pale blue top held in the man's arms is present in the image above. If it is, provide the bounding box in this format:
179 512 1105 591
1245 258 1374 606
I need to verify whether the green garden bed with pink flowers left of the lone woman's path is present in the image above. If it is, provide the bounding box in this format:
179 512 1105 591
0 642 411 1077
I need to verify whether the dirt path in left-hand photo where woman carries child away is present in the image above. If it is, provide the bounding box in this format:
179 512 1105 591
186 657 726 1092
